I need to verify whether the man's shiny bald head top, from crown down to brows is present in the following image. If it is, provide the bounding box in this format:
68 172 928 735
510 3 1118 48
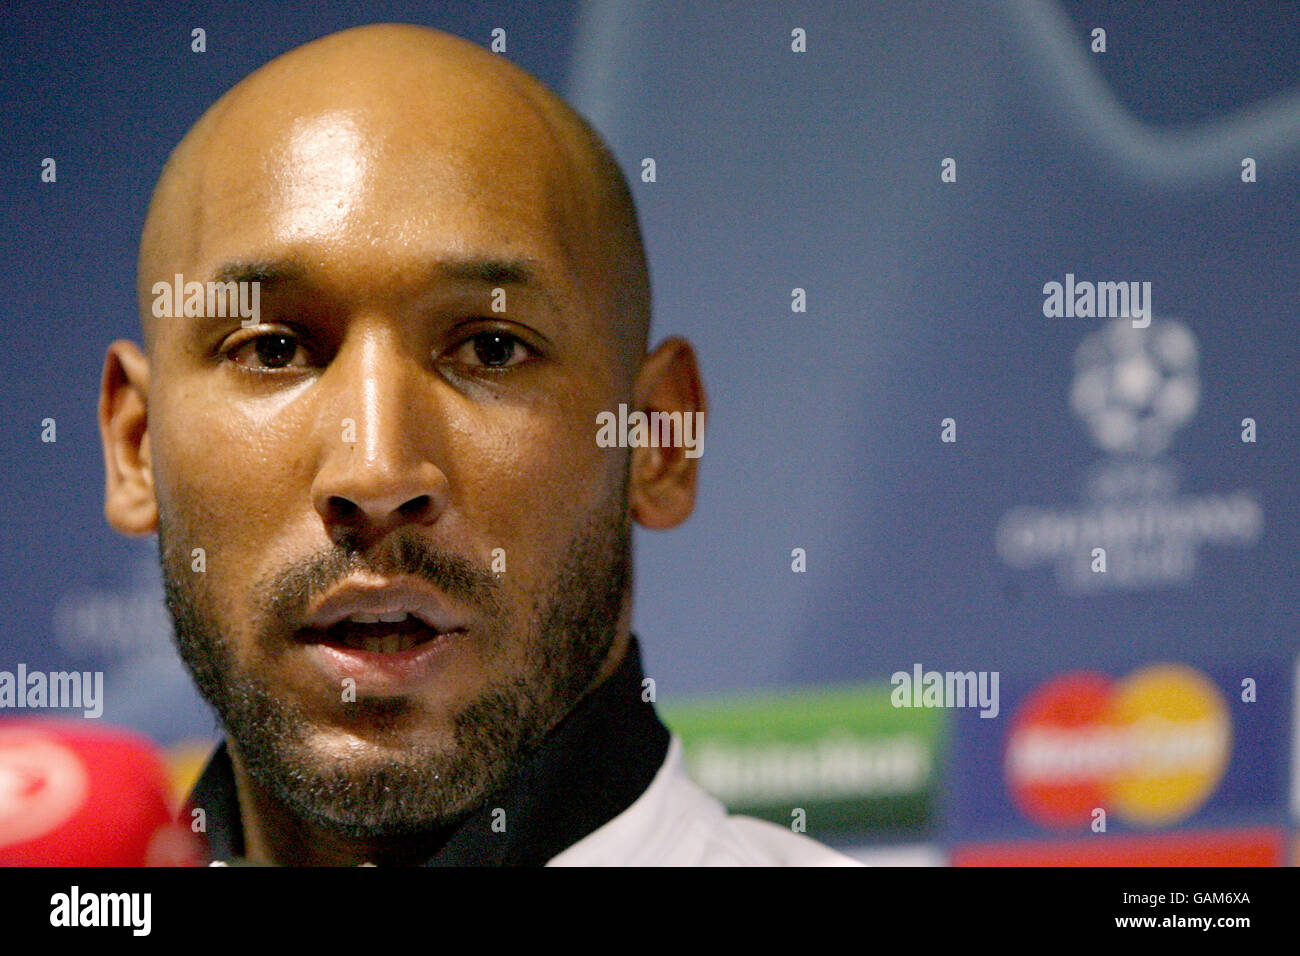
138 25 650 367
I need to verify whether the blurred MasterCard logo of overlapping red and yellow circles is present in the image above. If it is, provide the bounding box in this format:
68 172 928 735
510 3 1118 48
1004 663 1231 829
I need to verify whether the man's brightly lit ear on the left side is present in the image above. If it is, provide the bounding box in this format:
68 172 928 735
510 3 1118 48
99 341 159 535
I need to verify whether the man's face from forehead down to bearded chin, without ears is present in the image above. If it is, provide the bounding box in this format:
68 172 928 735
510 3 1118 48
137 78 629 834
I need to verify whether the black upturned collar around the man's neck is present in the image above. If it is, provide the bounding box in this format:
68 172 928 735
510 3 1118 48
189 637 668 866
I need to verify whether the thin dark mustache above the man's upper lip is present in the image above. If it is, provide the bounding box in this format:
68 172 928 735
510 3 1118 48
256 537 501 622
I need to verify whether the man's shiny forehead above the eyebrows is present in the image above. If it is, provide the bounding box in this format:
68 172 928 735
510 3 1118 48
186 77 586 295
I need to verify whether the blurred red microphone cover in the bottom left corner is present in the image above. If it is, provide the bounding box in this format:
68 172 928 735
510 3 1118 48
0 719 203 866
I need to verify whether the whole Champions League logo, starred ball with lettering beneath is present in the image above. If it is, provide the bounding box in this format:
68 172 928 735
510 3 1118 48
995 319 1264 593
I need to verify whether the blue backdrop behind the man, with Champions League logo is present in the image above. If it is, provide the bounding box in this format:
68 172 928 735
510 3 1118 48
0 0 1300 853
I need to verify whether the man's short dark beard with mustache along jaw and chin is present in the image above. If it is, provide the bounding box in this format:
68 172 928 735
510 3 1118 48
159 481 632 839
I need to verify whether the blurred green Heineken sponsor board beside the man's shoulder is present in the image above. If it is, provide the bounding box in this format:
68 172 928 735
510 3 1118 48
660 684 946 835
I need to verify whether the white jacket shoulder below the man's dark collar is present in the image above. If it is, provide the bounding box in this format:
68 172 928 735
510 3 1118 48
546 735 862 866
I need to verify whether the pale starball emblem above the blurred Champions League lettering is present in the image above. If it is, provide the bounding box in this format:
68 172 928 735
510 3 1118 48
1070 319 1200 458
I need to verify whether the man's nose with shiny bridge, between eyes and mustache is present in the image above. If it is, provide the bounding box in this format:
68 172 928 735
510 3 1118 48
312 327 449 544
